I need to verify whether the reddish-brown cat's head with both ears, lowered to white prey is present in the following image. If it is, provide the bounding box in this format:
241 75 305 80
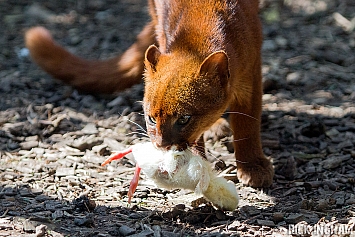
143 46 230 150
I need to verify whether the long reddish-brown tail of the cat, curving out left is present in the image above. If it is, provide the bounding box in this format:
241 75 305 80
25 23 155 94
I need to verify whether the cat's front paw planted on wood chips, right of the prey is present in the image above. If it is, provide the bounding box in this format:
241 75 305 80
237 158 274 188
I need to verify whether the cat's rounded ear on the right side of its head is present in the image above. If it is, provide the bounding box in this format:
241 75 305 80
199 51 230 84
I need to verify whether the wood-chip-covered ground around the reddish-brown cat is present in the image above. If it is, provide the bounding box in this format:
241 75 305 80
0 0 355 237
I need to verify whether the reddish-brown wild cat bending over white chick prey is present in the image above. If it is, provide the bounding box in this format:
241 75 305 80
26 0 274 187
